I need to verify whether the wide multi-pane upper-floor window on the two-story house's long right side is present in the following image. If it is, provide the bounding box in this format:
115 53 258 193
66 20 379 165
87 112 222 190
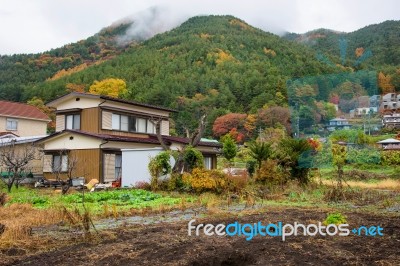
112 114 155 133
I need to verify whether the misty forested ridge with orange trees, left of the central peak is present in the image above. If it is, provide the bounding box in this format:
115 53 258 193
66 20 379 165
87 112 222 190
0 23 134 101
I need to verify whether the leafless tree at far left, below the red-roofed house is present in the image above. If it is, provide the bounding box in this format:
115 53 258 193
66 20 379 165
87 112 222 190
0 140 37 192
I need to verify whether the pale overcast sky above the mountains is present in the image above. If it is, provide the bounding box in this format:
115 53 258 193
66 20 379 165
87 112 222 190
0 0 400 55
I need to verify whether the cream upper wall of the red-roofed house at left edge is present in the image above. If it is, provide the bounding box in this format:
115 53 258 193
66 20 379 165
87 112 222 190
0 116 47 137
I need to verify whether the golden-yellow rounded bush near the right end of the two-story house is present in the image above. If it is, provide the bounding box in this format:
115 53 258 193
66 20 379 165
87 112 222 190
182 168 229 193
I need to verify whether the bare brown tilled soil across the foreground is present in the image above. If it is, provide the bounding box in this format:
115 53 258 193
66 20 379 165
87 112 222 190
0 209 400 265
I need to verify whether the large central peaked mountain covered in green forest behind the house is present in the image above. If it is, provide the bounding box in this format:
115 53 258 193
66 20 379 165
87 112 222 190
24 16 337 133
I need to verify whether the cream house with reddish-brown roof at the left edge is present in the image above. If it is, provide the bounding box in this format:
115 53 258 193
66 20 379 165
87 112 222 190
0 101 50 137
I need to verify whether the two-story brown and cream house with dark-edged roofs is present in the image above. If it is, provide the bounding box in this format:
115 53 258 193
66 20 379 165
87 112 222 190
39 92 220 186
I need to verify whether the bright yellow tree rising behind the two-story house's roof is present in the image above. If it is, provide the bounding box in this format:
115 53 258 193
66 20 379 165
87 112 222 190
89 78 127 97
